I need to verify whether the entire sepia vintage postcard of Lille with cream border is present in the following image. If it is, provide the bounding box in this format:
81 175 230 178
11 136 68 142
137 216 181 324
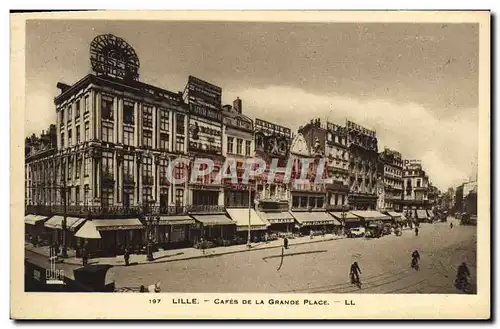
11 11 491 319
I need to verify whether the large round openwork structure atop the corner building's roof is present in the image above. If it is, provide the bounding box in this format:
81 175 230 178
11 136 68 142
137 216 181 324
90 34 139 80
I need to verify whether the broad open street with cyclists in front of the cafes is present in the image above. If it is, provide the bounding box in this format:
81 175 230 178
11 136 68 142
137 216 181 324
112 220 476 293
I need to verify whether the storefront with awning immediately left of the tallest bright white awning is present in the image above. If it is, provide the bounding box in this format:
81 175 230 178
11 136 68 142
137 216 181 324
192 214 236 242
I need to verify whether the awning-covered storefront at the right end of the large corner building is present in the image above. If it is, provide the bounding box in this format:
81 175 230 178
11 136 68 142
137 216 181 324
156 216 196 249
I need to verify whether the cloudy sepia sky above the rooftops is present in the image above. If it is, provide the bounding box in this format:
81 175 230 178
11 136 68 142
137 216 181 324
25 20 479 190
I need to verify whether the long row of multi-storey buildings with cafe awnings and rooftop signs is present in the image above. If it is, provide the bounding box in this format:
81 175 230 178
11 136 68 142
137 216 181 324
25 35 462 254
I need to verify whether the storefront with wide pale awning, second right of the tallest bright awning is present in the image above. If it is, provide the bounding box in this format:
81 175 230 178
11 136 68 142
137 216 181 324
291 211 341 235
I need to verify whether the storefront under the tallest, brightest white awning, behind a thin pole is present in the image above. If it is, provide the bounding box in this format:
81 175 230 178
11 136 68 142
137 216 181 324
227 208 268 242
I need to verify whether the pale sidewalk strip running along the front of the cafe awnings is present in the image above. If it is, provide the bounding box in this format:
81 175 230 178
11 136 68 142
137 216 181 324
25 234 344 266
